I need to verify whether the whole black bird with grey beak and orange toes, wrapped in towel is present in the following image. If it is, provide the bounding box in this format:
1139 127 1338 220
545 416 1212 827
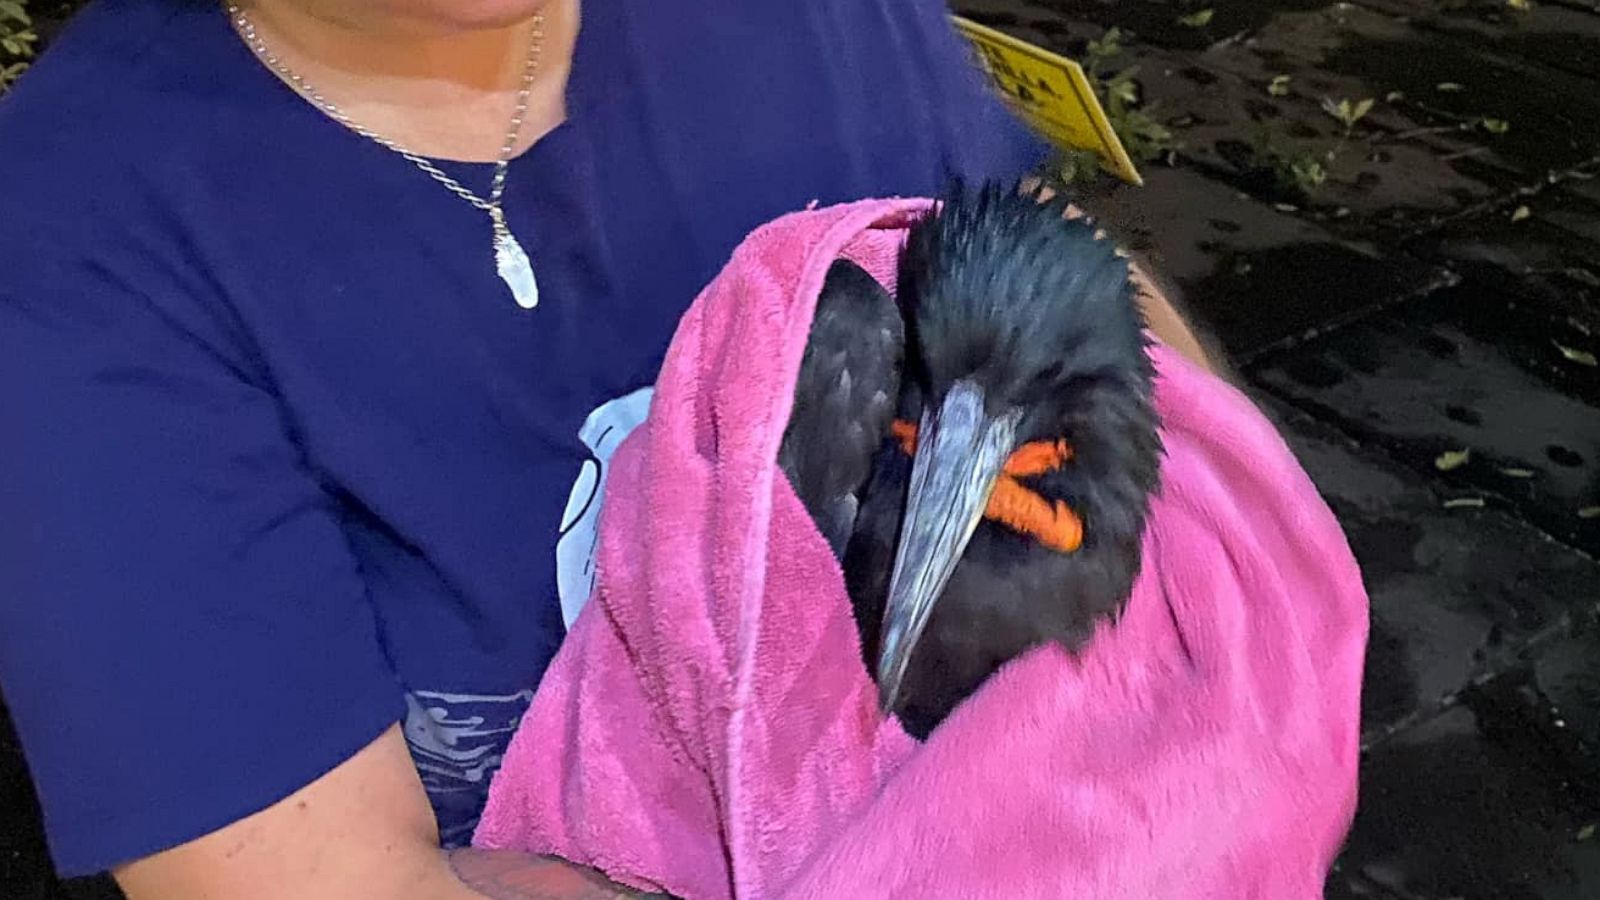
779 184 1162 738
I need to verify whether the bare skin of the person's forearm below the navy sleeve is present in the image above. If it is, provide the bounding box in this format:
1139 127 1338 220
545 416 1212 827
114 727 640 900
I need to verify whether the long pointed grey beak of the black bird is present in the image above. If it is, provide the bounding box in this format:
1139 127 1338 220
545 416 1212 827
878 381 1016 713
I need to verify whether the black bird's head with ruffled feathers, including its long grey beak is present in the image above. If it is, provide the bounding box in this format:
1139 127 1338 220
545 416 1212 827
878 184 1160 709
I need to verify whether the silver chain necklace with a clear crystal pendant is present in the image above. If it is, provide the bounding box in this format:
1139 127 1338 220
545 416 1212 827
227 2 544 309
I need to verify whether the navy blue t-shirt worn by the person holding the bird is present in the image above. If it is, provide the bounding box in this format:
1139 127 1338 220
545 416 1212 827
0 0 1043 873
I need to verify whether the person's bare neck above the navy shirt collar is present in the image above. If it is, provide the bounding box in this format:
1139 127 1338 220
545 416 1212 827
230 0 578 162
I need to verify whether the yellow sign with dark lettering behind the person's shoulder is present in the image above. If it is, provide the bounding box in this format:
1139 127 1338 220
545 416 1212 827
952 16 1144 184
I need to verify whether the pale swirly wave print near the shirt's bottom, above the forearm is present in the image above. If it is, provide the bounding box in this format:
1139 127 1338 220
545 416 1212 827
405 689 533 849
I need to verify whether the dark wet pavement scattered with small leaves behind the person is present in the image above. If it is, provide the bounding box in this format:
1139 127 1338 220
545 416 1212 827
9 0 1600 900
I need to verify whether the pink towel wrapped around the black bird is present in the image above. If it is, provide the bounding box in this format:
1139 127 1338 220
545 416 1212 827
477 200 1366 900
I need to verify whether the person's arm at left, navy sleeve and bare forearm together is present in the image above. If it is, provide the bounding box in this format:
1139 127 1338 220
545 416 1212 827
0 235 652 900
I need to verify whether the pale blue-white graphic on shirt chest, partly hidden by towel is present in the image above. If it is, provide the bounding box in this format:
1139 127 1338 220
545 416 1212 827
555 388 654 629
